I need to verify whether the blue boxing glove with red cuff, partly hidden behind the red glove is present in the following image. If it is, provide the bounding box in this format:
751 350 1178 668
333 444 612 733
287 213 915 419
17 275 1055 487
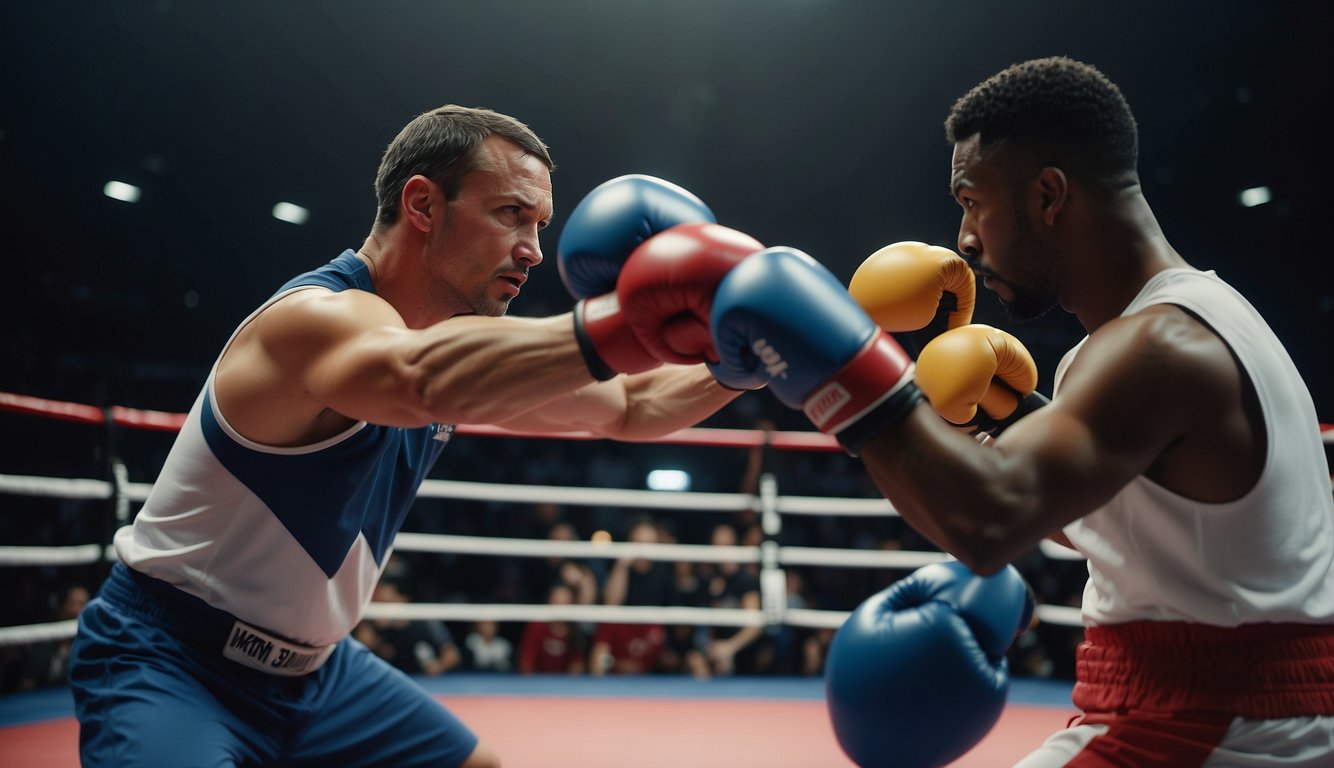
556 175 716 381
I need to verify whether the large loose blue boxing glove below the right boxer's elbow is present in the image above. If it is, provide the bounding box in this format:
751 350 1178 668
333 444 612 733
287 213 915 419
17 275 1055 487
824 561 1034 768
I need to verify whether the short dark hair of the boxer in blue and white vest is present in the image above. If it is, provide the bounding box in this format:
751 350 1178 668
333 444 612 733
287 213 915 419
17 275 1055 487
375 104 555 229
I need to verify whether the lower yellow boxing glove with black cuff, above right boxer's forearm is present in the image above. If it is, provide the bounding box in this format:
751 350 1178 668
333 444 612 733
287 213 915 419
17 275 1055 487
914 325 1050 436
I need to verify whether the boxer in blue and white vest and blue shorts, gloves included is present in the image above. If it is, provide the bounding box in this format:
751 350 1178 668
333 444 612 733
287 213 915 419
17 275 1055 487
69 105 760 768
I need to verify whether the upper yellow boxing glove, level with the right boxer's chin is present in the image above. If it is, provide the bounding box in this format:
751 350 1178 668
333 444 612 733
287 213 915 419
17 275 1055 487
847 241 978 341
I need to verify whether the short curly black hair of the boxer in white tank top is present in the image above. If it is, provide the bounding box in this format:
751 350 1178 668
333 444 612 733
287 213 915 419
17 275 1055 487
944 56 1139 179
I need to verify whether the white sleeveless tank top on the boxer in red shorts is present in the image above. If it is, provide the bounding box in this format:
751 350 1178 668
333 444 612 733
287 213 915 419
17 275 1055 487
1055 269 1334 627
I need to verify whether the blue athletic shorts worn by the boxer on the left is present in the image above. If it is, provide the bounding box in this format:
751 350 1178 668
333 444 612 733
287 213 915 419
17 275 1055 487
69 564 478 768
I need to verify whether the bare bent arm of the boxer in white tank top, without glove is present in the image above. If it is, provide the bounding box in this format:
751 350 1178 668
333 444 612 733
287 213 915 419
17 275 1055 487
862 308 1234 573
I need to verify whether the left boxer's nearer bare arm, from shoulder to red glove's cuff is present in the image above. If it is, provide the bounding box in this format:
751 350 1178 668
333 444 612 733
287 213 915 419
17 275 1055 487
216 289 592 445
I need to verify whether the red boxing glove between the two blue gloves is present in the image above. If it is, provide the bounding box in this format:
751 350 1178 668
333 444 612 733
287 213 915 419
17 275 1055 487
616 224 764 364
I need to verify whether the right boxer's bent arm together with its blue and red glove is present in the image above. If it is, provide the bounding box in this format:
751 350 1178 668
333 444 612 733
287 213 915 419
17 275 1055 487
712 248 1235 573
